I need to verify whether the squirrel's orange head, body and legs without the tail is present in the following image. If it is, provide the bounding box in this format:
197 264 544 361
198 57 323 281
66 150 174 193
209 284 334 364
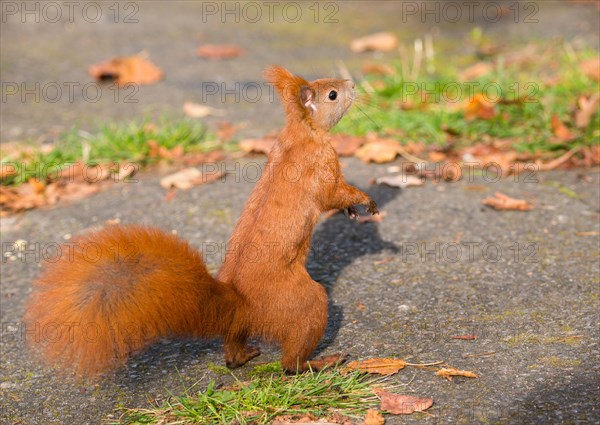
219 67 377 371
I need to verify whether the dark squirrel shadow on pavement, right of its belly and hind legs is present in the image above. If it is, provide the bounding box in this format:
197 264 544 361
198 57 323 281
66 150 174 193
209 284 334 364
306 186 400 355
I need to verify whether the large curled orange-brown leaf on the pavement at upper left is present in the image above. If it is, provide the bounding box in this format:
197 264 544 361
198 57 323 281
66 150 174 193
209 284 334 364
88 55 163 86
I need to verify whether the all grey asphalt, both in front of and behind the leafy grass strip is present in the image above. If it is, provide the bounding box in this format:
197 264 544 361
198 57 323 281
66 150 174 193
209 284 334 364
0 2 600 424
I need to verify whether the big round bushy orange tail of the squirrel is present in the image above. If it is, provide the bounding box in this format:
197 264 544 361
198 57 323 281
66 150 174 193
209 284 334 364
25 226 239 376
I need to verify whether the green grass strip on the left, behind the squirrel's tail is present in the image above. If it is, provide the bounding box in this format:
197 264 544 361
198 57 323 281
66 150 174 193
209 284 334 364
2 117 232 185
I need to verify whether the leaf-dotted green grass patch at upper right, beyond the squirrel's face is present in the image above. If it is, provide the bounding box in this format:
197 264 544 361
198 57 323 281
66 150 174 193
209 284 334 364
336 44 600 153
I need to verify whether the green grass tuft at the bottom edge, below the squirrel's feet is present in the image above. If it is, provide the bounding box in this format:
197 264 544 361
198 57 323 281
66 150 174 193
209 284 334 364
116 364 381 424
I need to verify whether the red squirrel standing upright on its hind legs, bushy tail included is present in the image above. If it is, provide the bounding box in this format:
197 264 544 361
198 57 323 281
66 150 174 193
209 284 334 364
25 66 378 377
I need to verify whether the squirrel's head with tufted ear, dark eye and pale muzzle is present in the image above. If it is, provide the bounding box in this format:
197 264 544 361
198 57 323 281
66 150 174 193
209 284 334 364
265 66 355 130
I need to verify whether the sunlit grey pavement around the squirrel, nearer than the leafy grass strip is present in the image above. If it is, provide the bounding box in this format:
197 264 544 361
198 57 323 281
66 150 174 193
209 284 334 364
0 159 600 424
